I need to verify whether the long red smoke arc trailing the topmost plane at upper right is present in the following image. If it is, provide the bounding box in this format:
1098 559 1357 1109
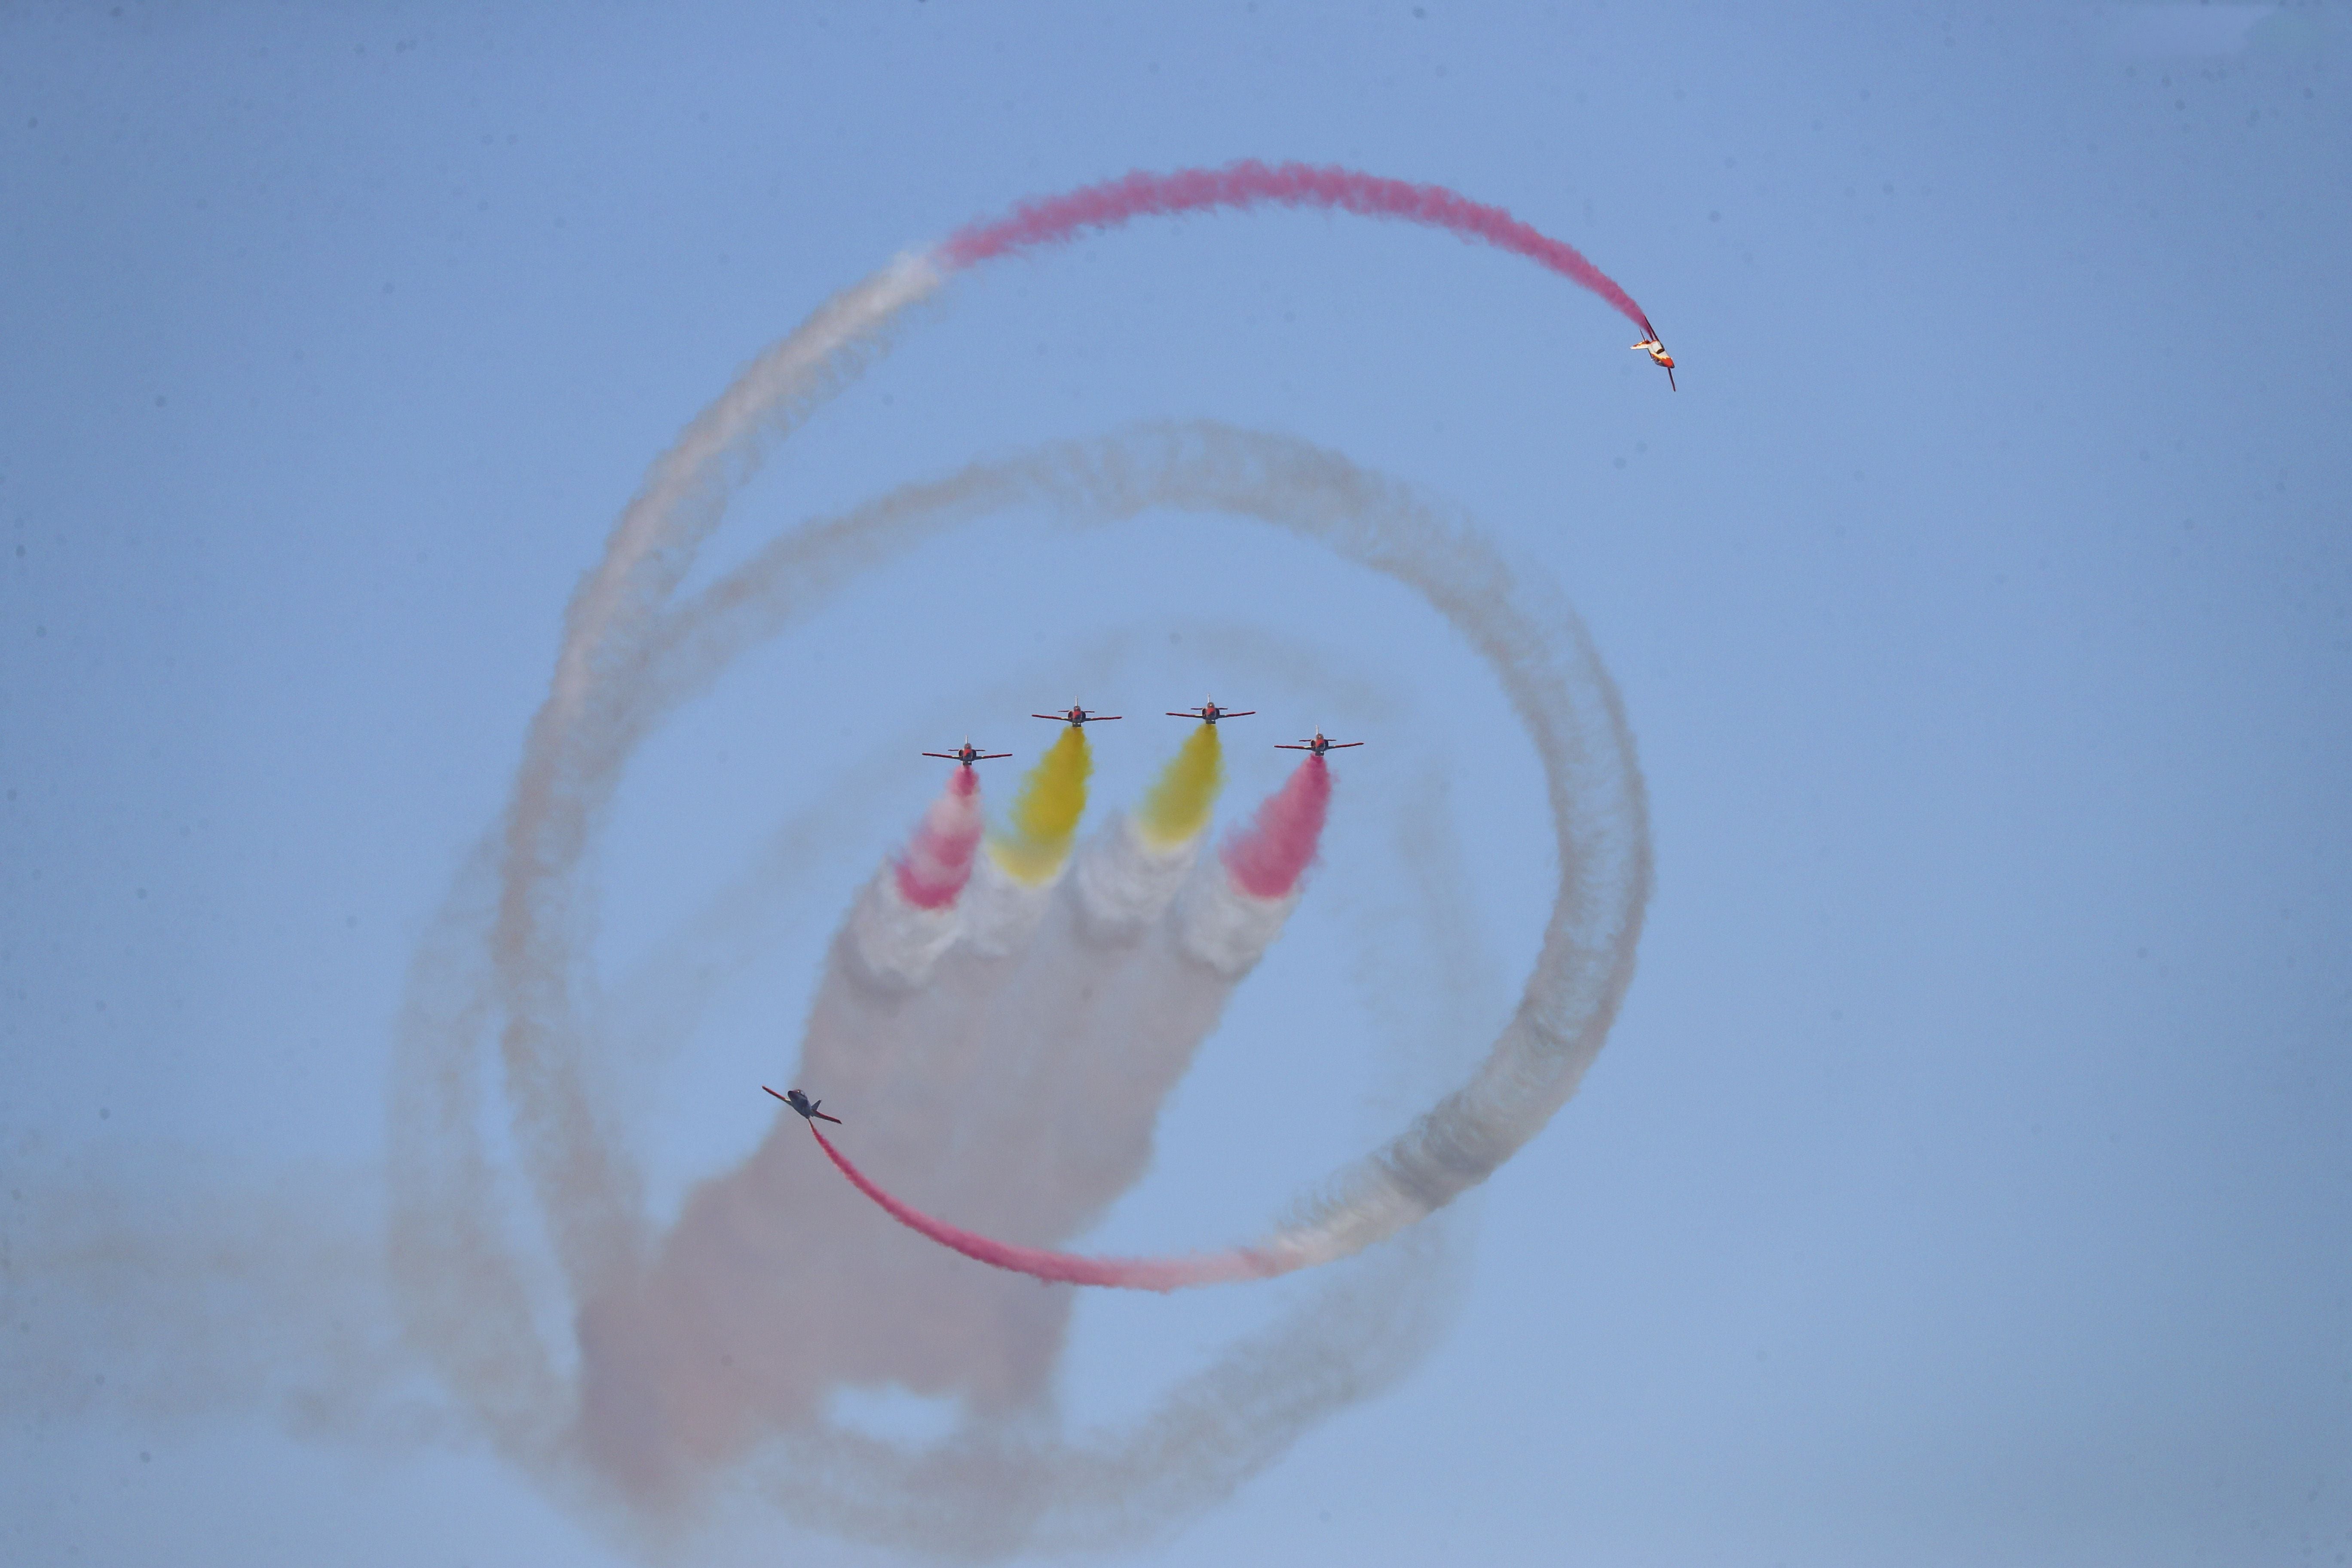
938 157 1656 336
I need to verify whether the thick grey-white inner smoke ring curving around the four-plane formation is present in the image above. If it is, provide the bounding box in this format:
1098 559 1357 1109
640 421 1649 1283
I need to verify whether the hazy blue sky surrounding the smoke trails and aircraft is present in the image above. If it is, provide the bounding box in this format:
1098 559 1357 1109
0 0 2352 1566
